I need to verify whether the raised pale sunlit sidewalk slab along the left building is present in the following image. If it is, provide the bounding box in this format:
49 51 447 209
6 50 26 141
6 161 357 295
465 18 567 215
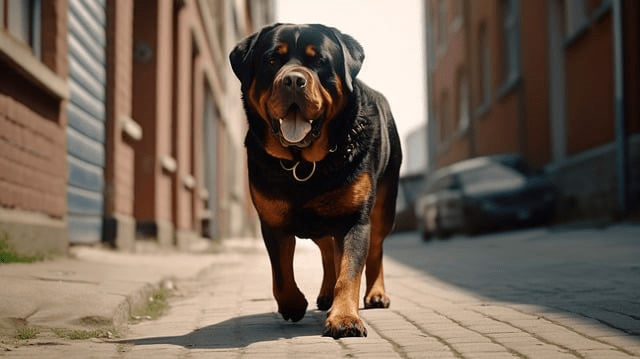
0 242 216 335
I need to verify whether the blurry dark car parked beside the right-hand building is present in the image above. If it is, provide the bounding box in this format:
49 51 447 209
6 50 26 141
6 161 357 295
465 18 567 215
415 155 559 240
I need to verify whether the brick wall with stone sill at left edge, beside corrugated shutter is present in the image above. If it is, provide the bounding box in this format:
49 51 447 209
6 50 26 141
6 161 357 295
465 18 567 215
0 0 68 254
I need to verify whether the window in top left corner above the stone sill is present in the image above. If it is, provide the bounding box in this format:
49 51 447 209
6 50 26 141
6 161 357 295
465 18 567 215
0 0 41 58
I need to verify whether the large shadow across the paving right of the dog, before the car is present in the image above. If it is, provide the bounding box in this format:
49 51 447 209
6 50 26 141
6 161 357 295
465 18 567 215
385 226 640 335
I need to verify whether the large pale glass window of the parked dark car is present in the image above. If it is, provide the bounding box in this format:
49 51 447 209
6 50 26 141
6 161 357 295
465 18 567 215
459 164 526 194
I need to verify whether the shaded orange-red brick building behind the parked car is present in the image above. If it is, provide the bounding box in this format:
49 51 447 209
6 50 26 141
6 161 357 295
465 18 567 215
426 0 640 217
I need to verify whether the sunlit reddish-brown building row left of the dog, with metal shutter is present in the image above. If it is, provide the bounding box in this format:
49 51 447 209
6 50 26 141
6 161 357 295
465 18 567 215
0 0 273 254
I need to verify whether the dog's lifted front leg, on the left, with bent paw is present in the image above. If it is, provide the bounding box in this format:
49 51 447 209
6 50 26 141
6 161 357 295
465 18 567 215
262 226 308 322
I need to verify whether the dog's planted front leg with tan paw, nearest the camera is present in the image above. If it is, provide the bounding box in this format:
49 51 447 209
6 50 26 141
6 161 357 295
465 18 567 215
322 223 371 339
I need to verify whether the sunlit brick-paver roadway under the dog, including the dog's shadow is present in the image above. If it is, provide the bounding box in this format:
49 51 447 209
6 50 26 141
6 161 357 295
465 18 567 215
0 226 640 359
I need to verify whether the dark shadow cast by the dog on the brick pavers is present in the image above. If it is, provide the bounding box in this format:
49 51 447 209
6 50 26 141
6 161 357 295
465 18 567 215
114 311 326 349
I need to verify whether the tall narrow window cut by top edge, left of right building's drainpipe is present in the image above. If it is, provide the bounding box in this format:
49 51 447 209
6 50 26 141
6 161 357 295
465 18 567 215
501 0 520 85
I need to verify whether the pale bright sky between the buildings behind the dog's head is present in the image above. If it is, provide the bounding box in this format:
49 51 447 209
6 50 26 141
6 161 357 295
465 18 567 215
276 0 427 173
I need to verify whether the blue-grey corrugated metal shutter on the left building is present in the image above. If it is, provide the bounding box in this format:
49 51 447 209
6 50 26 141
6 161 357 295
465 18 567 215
67 0 107 243
